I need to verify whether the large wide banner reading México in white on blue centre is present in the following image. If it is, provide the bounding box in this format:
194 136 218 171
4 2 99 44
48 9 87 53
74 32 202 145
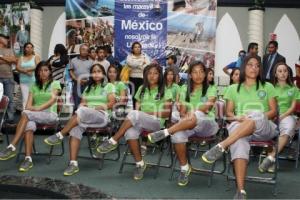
66 0 217 69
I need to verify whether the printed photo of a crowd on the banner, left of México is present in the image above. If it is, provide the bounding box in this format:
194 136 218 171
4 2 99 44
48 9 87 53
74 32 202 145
66 16 114 54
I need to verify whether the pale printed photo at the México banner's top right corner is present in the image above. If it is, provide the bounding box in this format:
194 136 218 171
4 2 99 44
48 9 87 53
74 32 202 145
172 0 217 16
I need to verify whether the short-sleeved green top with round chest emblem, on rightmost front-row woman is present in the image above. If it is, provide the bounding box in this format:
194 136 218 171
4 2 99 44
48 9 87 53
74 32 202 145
224 82 276 116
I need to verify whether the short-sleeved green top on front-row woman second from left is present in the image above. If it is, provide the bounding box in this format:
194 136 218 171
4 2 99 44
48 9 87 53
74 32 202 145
82 83 116 113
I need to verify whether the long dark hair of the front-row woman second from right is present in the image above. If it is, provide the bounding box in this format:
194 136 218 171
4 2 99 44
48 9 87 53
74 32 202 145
185 61 209 102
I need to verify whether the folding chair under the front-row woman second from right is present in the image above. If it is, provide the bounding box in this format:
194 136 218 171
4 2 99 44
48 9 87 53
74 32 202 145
169 100 227 187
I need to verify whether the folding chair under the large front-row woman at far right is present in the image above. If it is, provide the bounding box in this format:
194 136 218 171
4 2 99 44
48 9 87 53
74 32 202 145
227 113 280 195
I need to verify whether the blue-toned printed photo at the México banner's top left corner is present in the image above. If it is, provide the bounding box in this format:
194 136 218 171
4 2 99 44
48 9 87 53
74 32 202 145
66 0 115 20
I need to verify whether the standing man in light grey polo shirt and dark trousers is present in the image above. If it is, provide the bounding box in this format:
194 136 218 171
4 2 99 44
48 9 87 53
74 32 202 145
70 44 93 111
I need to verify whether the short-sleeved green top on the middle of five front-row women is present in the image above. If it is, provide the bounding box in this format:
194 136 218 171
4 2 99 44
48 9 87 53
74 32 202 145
134 86 172 127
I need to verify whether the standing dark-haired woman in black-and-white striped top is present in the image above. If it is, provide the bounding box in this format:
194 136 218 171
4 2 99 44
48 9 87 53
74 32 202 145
47 44 69 88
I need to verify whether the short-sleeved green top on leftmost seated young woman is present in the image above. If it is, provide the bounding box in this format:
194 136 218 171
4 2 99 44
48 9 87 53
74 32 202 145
30 81 61 113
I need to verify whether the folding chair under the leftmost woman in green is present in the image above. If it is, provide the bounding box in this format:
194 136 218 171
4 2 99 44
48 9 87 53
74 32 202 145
16 97 65 164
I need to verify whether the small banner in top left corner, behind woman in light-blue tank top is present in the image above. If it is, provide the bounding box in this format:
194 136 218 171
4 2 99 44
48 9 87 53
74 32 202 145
0 2 30 56
